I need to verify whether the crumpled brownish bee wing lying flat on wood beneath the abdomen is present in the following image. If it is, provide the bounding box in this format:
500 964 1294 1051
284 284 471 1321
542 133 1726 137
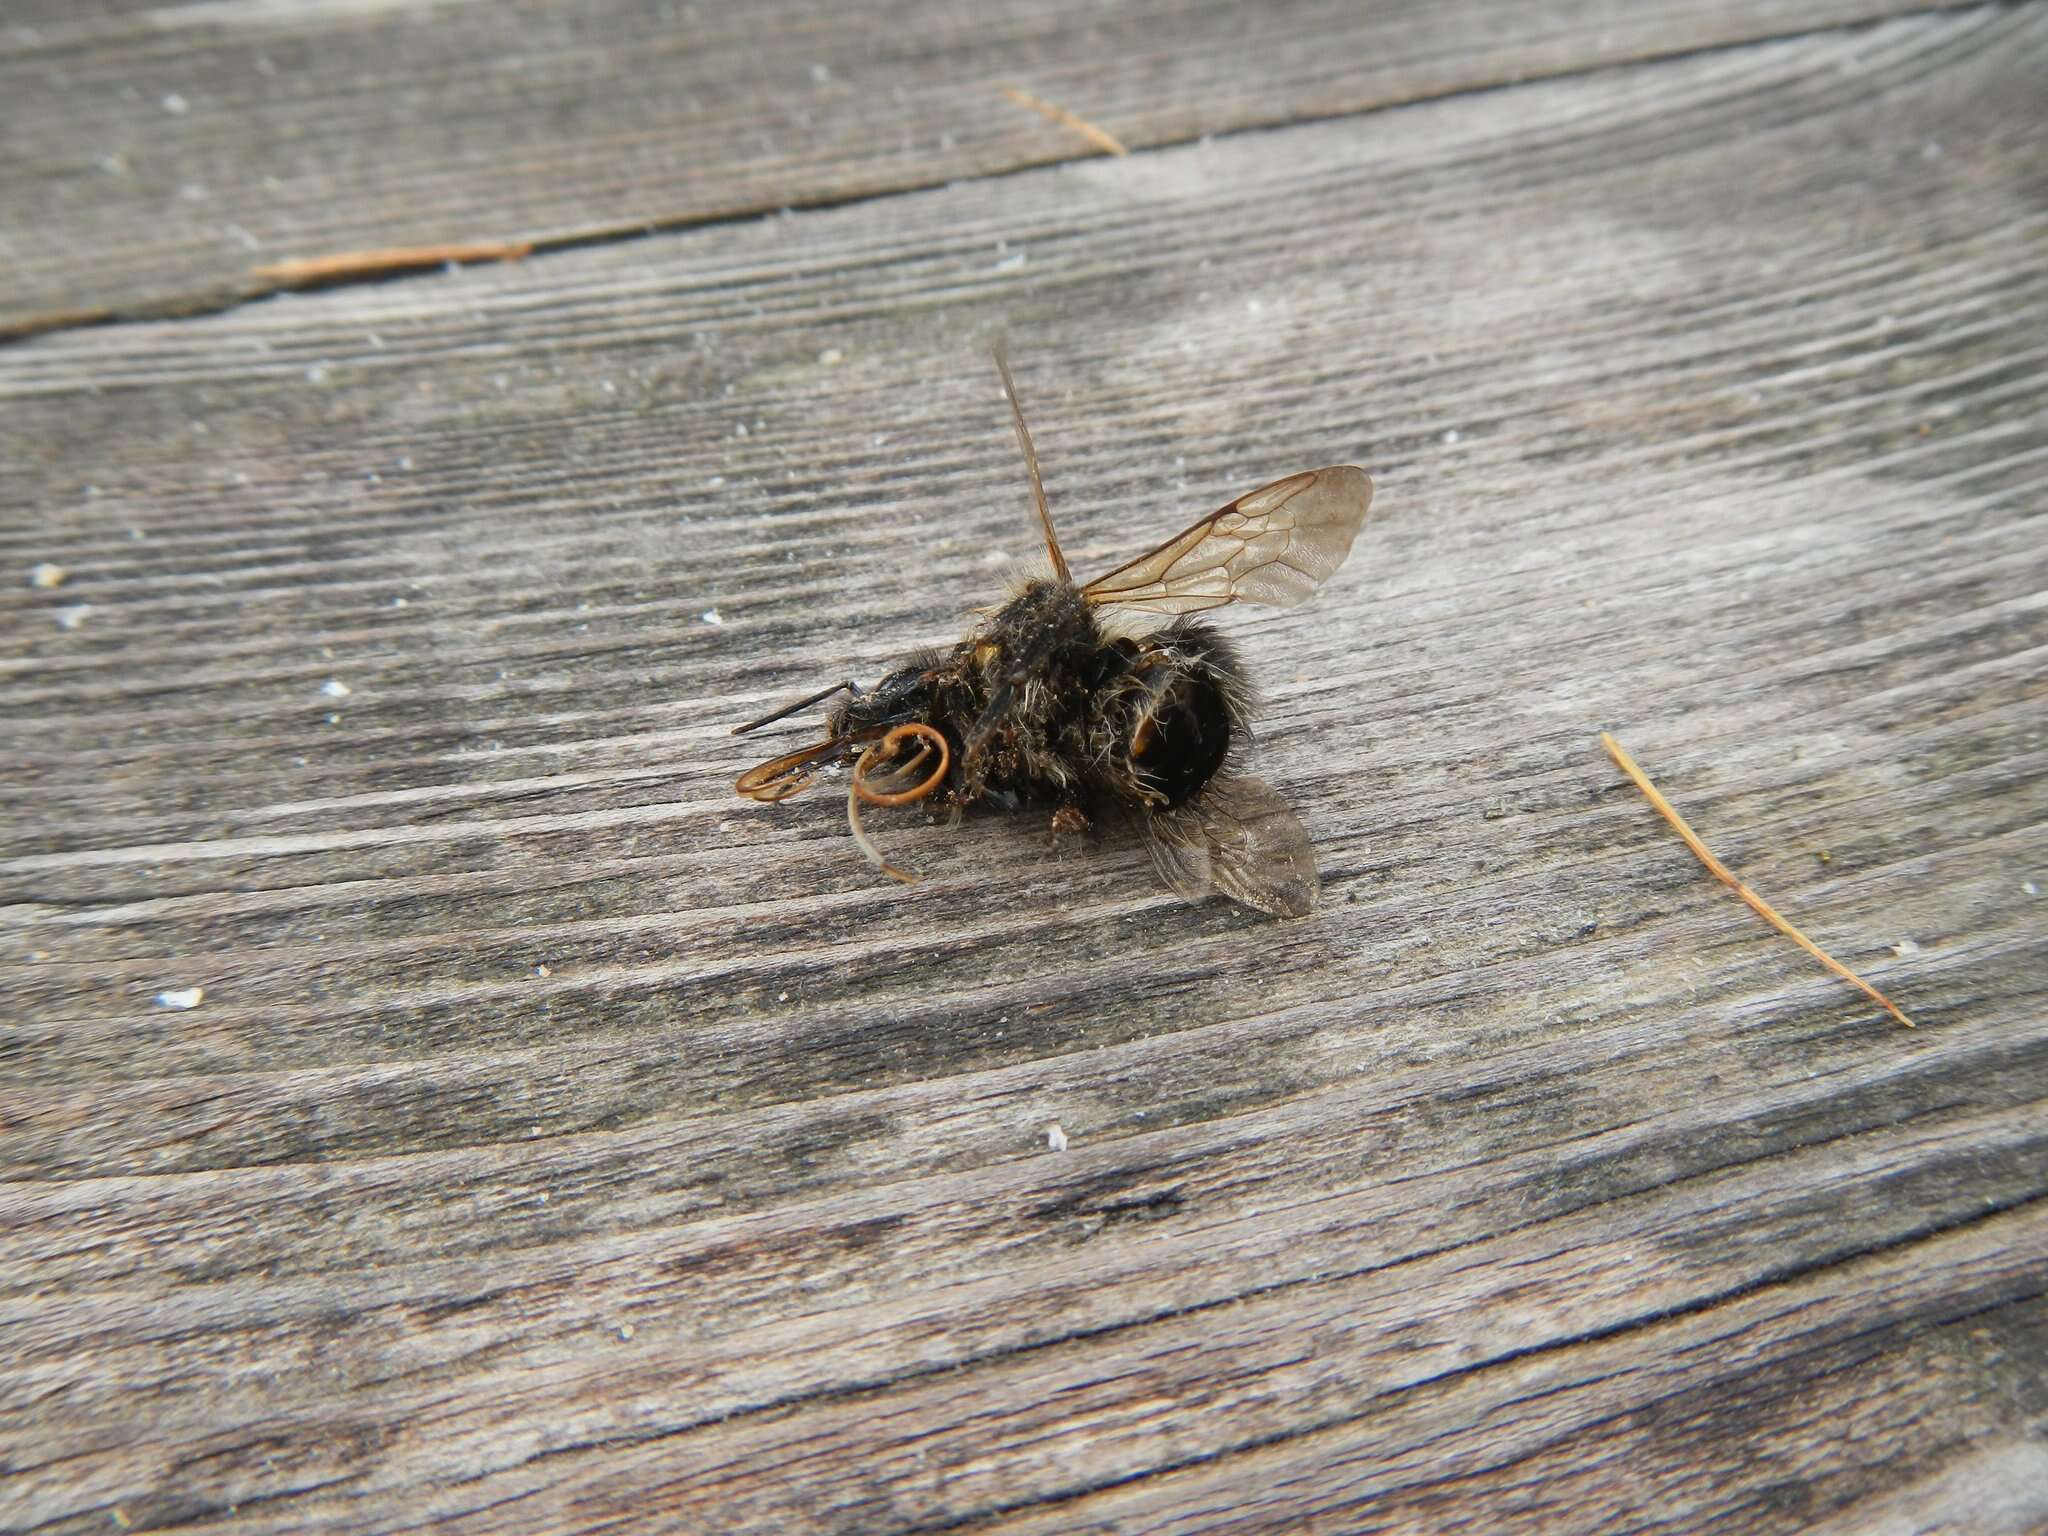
1147 778 1323 918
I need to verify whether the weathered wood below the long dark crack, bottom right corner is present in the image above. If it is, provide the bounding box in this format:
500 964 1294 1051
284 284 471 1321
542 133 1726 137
978 1217 2048 1532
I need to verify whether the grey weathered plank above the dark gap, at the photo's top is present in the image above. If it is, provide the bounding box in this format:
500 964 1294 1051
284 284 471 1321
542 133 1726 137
0 0 1982 336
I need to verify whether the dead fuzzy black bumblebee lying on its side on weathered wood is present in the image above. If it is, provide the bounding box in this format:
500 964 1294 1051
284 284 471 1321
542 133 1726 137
733 350 1372 918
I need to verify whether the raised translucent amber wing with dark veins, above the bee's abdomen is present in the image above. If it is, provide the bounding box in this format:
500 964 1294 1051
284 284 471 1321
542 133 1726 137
1081 465 1372 614
